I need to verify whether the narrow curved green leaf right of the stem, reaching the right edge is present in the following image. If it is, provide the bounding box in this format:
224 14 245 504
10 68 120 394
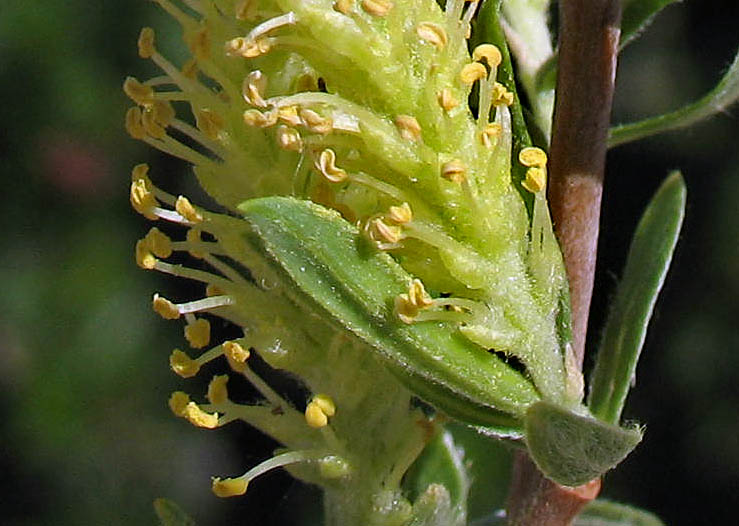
608 47 739 147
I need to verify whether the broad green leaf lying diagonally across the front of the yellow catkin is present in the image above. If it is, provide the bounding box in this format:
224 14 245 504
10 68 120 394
239 197 539 436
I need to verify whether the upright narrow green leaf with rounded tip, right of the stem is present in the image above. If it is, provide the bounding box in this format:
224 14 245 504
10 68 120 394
588 172 686 424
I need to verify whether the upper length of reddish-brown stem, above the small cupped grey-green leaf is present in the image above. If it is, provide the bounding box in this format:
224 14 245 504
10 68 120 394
548 0 621 367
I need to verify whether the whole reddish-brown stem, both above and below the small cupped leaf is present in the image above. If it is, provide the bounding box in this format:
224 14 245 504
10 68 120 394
507 0 621 526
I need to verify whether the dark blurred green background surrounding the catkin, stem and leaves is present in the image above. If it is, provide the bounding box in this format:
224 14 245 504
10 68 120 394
0 0 739 525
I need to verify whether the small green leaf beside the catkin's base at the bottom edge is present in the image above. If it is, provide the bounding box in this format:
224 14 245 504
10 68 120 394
403 430 470 517
